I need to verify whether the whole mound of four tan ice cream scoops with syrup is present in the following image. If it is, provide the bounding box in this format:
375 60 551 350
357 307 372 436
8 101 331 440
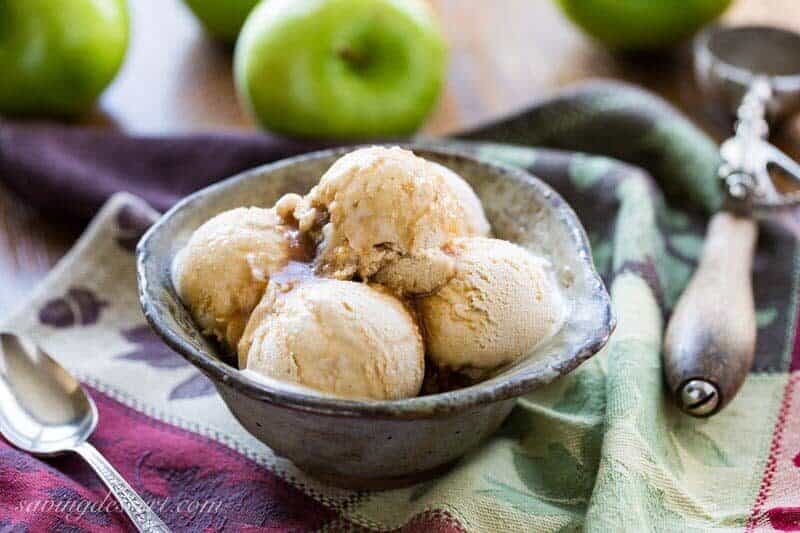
173 146 566 400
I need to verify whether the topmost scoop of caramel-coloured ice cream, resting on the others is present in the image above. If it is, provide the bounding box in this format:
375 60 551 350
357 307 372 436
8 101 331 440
308 146 467 279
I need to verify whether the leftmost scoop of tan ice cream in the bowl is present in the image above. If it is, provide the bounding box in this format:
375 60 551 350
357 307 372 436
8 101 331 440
172 207 294 349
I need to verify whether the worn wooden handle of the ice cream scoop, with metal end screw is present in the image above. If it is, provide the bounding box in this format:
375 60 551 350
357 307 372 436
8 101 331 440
664 212 758 416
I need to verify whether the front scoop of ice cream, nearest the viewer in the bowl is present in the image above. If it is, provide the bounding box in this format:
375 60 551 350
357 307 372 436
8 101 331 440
239 278 425 400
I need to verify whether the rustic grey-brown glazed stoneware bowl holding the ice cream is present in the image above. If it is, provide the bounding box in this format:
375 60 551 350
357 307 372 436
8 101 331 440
137 146 614 488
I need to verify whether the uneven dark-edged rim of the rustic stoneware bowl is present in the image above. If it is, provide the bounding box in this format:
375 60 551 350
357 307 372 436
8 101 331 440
136 142 616 419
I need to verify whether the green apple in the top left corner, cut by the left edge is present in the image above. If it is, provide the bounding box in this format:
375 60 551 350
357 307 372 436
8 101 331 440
0 0 128 116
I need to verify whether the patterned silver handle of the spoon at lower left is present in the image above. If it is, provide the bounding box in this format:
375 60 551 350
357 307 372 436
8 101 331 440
73 442 170 533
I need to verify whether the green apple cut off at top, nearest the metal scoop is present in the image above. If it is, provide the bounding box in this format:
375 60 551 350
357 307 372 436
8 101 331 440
557 0 731 51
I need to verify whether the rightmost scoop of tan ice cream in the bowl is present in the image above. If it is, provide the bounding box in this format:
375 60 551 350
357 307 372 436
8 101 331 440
418 237 564 370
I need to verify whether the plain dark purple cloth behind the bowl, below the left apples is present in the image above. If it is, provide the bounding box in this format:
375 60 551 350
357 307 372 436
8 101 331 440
0 122 325 220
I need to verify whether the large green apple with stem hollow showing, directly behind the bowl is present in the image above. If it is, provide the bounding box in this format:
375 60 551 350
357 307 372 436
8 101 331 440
234 0 447 139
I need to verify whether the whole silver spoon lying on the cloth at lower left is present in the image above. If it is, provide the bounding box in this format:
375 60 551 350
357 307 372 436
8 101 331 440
0 333 169 533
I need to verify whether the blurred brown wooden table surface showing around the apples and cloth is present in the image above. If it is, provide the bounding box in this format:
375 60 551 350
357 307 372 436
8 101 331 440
0 0 800 317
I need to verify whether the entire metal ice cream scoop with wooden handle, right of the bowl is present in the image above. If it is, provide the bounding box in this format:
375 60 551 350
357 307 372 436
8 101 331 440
664 26 800 416
